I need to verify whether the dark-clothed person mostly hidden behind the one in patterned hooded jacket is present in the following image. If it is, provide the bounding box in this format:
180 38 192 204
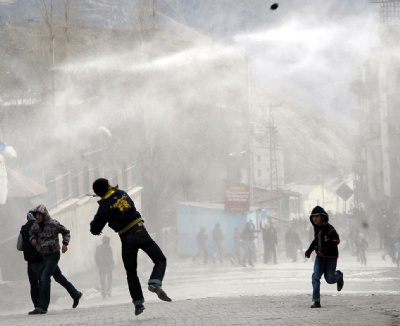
17 211 43 308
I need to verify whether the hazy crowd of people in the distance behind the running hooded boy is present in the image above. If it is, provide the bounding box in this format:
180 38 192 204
192 209 400 267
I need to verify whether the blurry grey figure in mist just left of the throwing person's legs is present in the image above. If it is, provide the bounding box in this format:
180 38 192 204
95 235 114 299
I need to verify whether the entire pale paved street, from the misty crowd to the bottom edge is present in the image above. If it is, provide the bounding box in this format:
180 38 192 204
0 251 400 326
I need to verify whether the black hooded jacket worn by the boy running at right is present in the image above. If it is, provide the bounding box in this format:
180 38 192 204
307 206 340 259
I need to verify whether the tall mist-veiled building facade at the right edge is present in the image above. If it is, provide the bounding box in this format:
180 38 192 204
353 26 400 218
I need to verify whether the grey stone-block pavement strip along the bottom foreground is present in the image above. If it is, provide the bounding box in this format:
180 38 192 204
0 294 400 326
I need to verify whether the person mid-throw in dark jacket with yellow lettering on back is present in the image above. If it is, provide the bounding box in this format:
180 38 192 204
90 178 172 315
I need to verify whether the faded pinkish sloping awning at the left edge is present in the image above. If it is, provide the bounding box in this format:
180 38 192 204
6 167 47 198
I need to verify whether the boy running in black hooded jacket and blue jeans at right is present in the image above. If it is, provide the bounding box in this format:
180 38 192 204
305 206 344 308
